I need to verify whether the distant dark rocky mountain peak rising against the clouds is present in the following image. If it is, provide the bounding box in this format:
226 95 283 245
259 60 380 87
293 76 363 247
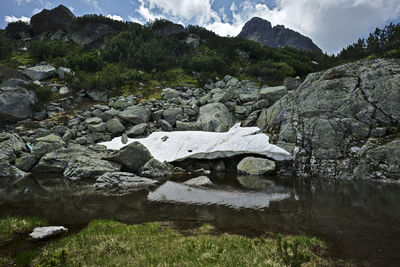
238 17 322 53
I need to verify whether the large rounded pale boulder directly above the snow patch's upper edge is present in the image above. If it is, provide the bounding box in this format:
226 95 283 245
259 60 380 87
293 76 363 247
197 102 233 132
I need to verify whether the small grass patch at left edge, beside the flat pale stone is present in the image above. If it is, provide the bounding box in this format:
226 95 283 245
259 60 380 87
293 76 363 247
0 217 45 242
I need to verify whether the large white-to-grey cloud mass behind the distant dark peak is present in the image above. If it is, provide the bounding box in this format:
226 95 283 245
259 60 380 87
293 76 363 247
137 0 400 53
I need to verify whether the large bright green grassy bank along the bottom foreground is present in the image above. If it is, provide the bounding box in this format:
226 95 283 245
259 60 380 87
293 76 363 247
27 221 350 266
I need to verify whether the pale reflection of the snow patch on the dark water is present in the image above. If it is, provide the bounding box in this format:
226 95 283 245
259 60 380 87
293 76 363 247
147 181 290 209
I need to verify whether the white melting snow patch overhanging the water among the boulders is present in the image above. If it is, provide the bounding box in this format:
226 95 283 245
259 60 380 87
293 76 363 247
100 124 291 162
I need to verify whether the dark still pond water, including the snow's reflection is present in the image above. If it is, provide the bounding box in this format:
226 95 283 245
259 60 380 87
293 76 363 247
0 174 400 266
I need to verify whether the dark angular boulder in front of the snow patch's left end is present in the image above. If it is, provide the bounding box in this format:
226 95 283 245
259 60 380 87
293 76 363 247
106 142 152 172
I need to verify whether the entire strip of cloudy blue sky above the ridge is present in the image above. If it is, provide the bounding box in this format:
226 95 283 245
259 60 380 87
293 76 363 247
0 0 400 54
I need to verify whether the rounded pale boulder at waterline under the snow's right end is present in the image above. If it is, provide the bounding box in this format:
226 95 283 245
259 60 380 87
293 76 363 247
237 157 276 175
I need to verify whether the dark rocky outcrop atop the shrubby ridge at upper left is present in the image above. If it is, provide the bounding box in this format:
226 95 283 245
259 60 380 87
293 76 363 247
30 5 75 33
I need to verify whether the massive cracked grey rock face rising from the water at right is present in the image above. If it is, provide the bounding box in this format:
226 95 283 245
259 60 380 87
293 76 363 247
257 59 400 179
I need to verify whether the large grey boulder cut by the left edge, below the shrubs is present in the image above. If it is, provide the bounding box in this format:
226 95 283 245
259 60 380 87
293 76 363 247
0 87 38 122
